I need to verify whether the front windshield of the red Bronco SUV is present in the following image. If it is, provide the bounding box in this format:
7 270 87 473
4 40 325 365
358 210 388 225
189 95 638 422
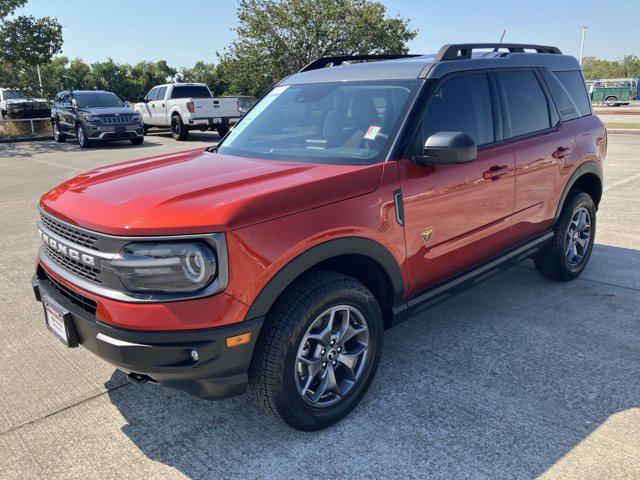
218 80 420 164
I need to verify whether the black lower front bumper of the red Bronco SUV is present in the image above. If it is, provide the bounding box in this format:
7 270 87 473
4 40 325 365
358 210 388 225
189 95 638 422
32 269 264 399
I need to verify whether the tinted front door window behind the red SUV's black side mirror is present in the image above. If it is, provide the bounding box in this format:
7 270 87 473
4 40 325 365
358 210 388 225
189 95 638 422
422 73 494 145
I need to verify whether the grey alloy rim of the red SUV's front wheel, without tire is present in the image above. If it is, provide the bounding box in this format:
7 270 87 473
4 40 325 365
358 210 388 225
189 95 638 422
295 305 369 407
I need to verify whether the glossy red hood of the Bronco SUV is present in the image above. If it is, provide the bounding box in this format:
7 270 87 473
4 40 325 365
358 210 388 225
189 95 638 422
40 149 382 235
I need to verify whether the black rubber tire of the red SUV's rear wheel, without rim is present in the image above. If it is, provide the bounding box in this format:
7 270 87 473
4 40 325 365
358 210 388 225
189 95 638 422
533 191 596 281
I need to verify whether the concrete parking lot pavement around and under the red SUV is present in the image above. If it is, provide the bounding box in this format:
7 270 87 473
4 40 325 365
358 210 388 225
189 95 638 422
0 133 640 479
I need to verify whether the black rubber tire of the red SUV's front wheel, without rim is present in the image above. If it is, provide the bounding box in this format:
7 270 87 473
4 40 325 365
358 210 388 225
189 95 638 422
249 271 384 431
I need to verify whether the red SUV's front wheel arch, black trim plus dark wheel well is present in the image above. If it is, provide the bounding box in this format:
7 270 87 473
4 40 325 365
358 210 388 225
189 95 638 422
245 237 404 327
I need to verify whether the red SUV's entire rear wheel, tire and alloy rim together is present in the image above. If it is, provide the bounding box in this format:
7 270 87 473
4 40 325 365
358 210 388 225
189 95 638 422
534 192 596 281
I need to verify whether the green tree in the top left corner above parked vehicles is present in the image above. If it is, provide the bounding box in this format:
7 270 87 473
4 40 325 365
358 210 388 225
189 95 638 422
0 0 62 92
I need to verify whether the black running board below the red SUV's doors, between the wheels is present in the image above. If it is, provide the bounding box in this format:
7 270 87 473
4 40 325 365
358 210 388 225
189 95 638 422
393 231 553 325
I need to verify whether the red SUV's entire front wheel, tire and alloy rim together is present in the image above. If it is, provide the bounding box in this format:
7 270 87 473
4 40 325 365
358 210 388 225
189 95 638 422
249 272 384 431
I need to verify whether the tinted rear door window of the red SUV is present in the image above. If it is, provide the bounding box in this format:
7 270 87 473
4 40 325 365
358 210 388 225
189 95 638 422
498 70 551 137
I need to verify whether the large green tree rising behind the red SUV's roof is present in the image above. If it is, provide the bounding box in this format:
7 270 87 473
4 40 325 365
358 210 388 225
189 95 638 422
218 0 417 96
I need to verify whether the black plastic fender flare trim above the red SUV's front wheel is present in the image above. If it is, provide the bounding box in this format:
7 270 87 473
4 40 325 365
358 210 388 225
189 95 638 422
245 237 404 320
